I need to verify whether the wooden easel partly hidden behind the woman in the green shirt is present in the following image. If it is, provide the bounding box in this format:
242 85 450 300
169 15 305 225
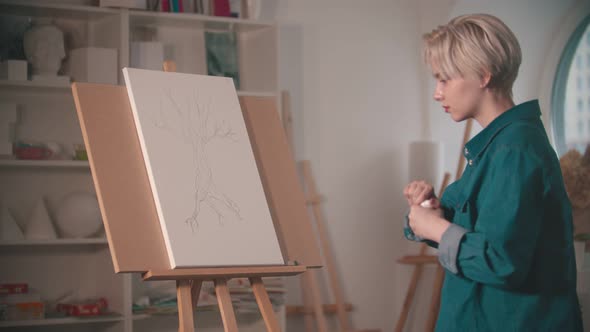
394 119 473 332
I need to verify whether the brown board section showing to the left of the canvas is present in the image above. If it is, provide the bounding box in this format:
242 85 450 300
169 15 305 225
72 83 170 272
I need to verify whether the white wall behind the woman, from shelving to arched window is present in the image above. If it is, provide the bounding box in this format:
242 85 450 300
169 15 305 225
276 0 582 331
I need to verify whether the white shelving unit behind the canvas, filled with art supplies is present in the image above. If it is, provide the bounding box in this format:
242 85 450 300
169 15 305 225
0 0 280 332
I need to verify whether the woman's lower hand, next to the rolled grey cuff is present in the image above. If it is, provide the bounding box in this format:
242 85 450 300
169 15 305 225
408 205 450 242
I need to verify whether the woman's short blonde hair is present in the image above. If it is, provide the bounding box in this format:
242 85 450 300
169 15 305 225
423 14 522 97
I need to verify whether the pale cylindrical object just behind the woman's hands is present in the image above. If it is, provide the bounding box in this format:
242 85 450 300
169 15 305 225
409 141 444 190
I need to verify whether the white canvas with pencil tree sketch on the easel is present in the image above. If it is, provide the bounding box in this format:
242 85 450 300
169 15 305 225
123 68 284 268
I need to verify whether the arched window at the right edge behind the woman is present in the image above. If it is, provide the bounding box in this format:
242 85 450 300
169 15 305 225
551 16 590 155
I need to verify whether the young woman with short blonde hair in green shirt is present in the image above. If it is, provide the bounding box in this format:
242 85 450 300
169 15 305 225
404 14 582 332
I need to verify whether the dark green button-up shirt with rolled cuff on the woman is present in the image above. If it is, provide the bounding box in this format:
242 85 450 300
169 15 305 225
406 100 582 332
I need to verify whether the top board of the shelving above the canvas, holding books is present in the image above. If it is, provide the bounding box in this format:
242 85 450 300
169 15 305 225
129 10 274 32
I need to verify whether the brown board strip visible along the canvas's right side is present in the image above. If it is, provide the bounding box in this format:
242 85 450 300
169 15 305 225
240 97 322 267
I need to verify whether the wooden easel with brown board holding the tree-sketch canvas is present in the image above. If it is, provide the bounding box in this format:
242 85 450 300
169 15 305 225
72 63 321 332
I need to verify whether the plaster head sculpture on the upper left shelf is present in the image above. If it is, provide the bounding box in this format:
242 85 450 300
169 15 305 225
23 19 66 76
